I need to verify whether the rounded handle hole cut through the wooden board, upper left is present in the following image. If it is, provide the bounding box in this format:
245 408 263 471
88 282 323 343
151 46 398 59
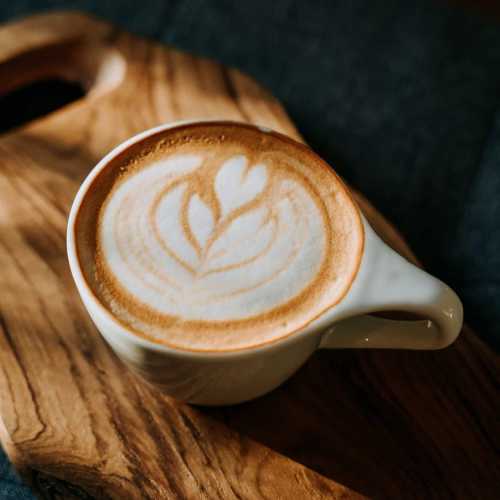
0 40 125 133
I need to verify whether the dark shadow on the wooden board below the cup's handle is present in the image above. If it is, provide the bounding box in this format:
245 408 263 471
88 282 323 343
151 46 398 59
204 326 500 498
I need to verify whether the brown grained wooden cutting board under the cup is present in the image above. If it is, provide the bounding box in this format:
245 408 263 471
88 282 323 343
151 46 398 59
0 13 500 500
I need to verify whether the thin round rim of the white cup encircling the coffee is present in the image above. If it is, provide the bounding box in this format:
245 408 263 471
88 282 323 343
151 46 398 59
66 119 366 360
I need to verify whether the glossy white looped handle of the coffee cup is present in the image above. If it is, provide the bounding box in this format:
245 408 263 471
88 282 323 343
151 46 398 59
319 221 463 349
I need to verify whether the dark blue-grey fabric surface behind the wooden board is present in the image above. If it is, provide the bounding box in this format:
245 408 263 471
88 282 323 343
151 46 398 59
0 0 500 498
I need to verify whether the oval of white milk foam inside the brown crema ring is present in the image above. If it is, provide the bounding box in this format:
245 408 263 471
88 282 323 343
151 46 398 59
97 153 327 322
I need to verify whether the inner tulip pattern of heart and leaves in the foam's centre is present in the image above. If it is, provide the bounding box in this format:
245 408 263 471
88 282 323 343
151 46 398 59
157 155 271 277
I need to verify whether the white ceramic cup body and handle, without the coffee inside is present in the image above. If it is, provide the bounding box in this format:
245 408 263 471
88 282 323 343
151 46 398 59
67 122 463 405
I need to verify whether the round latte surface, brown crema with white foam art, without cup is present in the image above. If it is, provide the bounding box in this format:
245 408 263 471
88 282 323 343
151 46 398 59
76 122 363 351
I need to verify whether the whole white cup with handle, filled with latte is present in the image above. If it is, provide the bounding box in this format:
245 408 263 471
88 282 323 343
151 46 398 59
67 121 463 405
